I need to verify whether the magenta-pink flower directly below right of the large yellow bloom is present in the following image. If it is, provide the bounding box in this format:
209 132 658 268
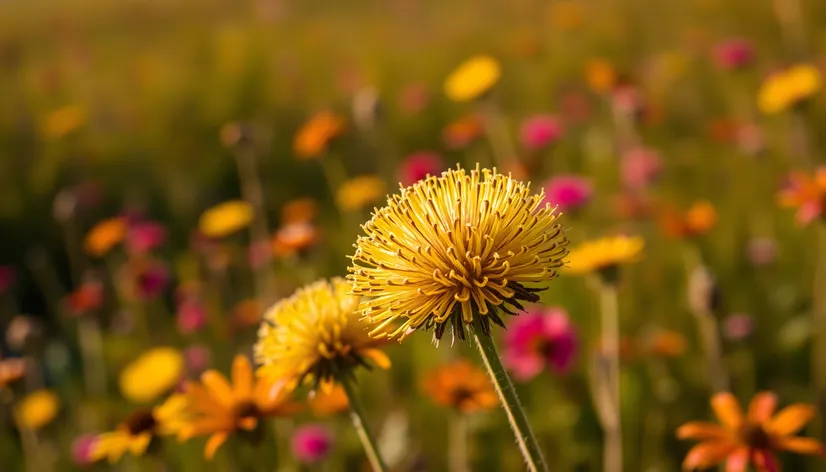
503 308 579 381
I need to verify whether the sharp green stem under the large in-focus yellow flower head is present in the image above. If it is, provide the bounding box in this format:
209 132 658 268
474 328 548 472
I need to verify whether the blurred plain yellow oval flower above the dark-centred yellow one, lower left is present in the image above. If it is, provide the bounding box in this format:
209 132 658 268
119 347 184 403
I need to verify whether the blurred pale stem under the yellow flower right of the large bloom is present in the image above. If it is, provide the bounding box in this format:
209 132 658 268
597 283 622 472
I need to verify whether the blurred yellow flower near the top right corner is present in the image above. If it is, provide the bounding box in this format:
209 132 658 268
757 64 823 115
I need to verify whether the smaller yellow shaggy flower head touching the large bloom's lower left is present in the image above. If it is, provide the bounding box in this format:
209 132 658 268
255 278 390 392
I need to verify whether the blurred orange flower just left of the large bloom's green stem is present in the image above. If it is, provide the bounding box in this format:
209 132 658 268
422 360 499 413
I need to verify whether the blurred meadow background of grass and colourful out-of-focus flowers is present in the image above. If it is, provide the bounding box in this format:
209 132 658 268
0 0 826 472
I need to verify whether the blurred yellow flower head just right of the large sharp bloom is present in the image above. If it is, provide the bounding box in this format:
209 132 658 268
567 235 645 275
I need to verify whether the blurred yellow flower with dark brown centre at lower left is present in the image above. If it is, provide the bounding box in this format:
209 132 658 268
89 395 188 463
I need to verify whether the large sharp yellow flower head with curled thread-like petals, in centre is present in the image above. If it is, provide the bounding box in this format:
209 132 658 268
348 168 568 341
